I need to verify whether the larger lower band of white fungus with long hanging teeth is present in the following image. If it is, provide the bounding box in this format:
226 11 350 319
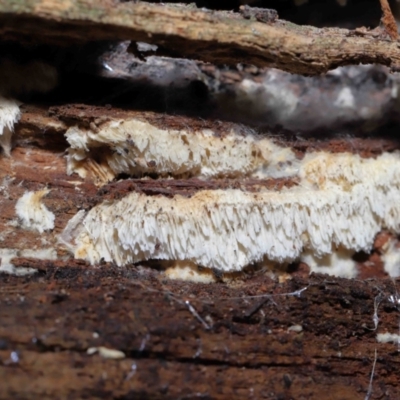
63 147 400 275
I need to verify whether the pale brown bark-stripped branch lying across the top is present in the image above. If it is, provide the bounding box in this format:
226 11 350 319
0 0 400 75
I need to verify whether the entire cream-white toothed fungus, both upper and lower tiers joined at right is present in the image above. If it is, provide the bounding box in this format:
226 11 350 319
63 113 400 276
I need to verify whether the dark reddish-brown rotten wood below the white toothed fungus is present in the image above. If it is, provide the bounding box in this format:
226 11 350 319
0 259 400 400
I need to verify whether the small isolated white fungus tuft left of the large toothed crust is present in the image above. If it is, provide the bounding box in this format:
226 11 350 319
15 189 55 233
